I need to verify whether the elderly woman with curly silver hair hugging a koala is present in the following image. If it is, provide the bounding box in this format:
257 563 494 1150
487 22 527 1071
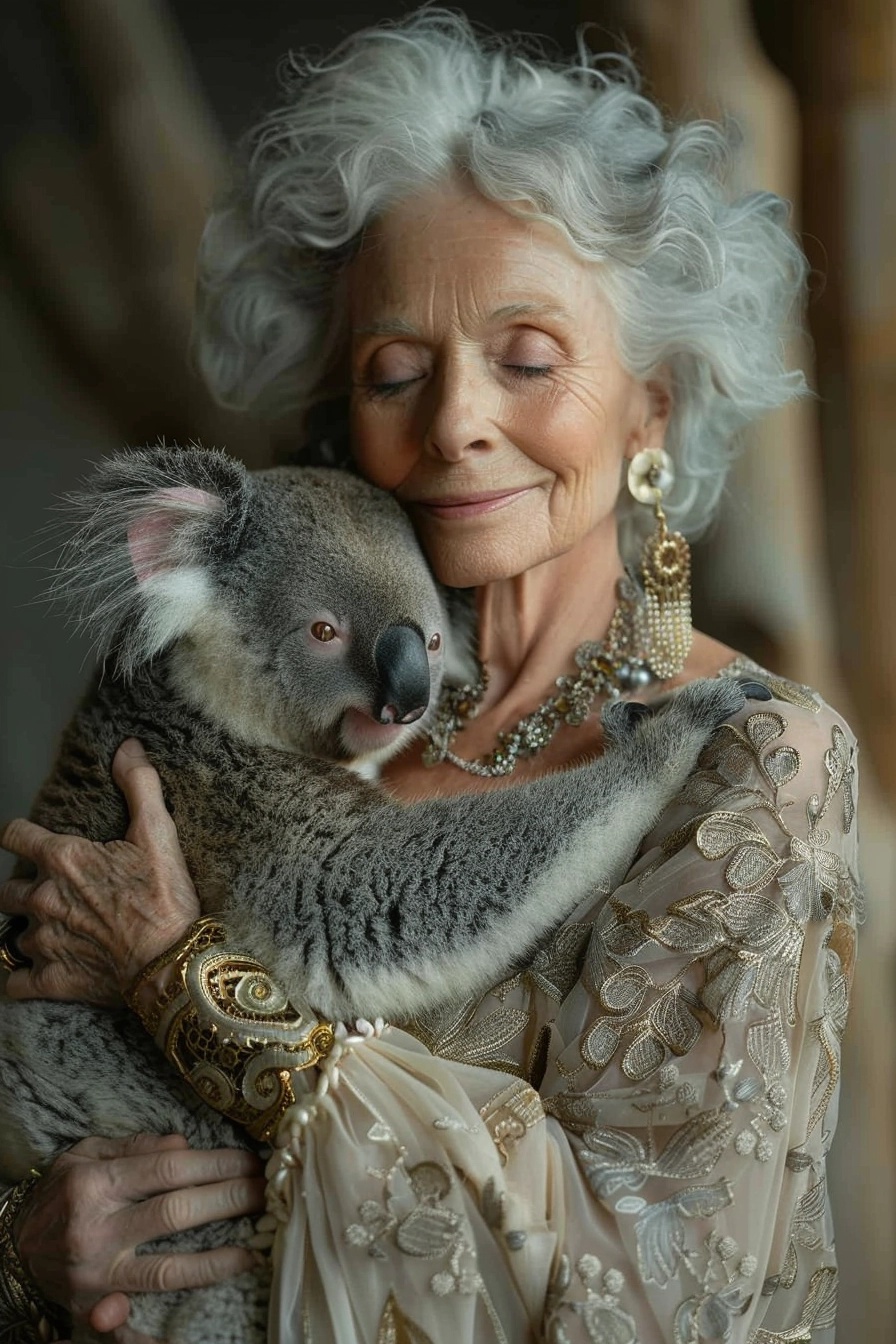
0 11 857 1344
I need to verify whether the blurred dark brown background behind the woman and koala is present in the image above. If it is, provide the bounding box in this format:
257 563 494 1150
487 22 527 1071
0 0 896 1344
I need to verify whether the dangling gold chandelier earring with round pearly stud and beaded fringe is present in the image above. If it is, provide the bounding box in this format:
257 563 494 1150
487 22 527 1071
629 448 693 681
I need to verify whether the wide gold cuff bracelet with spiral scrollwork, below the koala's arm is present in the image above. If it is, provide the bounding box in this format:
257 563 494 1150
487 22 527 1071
125 918 333 1141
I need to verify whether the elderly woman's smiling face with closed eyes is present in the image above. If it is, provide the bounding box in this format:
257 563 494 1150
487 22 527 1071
348 185 669 587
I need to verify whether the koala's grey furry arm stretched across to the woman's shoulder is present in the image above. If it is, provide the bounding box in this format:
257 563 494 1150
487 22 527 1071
227 679 744 1017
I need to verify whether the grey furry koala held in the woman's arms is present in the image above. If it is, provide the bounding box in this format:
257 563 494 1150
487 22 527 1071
0 449 744 1344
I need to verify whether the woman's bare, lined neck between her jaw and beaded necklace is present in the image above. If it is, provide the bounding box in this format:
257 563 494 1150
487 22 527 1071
477 527 622 718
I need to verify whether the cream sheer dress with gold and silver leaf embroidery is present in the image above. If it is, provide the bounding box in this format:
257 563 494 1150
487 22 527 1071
260 660 860 1344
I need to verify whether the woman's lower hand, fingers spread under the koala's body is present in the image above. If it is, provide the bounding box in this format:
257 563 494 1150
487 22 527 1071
16 1134 265 1344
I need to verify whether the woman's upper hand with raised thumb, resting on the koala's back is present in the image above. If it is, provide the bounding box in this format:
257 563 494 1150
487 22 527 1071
0 738 200 1004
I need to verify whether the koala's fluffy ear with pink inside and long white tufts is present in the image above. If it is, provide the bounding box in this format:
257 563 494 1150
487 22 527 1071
51 448 253 676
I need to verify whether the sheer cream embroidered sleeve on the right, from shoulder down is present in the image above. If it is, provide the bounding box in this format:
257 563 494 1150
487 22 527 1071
531 672 860 1344
